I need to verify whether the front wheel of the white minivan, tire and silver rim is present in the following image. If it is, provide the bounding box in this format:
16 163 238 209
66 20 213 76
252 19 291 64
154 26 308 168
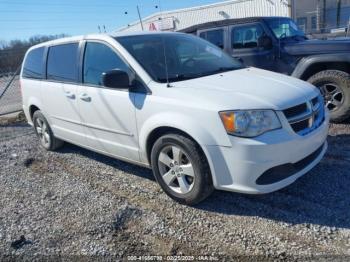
151 134 214 205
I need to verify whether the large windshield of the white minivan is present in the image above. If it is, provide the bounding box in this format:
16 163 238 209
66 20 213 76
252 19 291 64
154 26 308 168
116 33 243 83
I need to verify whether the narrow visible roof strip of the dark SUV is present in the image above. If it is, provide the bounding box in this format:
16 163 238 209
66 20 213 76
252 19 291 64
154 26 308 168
179 16 290 33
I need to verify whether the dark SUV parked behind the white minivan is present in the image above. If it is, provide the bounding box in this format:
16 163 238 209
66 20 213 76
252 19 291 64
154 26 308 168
181 17 350 122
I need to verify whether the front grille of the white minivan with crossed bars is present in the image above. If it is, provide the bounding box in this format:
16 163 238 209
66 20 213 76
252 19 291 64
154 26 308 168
283 96 324 136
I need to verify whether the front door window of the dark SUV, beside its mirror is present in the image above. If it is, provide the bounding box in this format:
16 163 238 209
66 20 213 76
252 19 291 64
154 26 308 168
231 24 263 49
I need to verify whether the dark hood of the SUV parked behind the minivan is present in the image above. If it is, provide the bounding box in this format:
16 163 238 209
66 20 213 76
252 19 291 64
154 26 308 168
284 40 350 55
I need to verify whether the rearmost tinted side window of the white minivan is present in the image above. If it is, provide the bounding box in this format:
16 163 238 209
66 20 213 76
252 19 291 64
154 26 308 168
22 47 45 79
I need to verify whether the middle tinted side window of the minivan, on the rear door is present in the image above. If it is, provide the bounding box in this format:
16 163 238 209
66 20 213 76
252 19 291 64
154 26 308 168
47 43 78 82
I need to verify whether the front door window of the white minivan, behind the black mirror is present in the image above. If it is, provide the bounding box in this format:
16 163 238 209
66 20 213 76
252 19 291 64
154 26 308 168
83 42 130 86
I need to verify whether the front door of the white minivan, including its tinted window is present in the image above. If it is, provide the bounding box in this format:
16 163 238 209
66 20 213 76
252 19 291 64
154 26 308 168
78 41 139 162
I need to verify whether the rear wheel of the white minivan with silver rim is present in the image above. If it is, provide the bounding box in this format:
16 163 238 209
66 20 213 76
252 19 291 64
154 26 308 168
33 110 64 151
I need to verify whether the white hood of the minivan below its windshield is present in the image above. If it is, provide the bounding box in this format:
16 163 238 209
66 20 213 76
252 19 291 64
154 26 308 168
171 68 319 110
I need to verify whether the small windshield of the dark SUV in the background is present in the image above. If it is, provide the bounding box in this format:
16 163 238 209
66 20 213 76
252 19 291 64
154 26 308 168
267 18 306 39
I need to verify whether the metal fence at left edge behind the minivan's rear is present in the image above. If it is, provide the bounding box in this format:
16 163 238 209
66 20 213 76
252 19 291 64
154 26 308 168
0 67 22 116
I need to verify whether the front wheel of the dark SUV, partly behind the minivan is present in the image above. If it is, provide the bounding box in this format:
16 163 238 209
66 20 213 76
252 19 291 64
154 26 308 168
308 70 350 123
